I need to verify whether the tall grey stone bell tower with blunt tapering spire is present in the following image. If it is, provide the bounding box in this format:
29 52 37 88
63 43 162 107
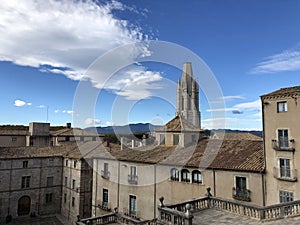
176 62 201 129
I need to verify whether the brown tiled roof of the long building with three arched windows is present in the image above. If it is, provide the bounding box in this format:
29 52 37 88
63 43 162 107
85 139 264 172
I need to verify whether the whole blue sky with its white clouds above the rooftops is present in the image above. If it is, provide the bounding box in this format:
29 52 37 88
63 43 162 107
0 0 300 130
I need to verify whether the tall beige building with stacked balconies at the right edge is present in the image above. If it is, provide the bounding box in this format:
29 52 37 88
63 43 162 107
261 87 300 205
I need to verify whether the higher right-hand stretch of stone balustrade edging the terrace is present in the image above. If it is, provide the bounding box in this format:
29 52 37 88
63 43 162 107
158 188 300 225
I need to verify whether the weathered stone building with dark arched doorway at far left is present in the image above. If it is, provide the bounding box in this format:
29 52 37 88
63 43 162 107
0 147 63 222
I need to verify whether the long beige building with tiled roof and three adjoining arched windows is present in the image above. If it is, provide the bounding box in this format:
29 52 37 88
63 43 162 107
92 135 264 219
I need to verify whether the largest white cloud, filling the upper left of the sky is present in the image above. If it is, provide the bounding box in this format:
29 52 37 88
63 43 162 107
0 0 161 99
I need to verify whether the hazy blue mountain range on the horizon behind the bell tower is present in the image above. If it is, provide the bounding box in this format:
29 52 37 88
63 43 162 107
85 123 263 137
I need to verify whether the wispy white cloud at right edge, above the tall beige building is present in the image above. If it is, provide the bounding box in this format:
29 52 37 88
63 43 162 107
250 49 300 74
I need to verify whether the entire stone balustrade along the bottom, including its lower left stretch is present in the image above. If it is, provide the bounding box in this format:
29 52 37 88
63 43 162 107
76 191 300 225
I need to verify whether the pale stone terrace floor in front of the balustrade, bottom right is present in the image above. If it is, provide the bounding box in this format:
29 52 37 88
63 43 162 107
193 209 300 225
